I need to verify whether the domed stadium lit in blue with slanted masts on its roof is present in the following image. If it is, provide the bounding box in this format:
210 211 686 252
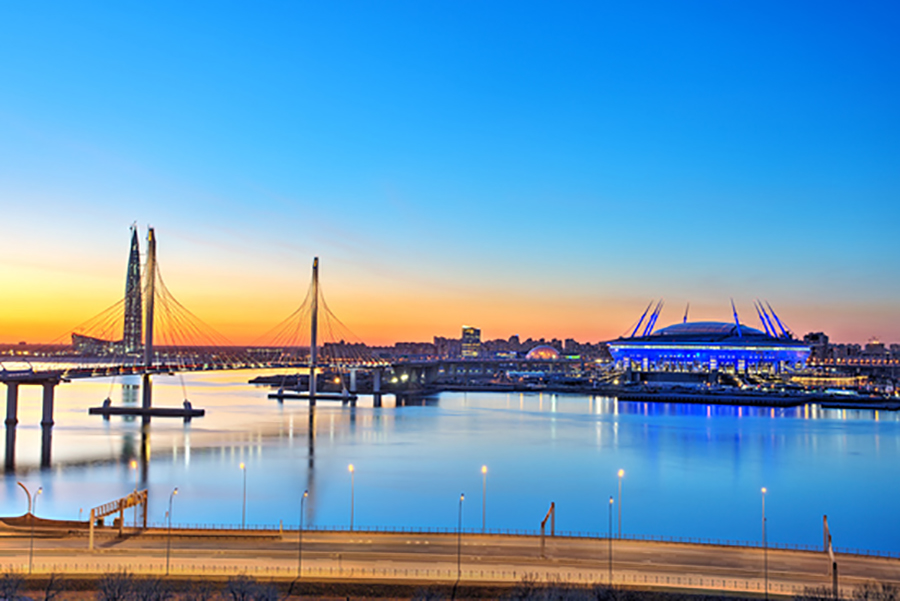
609 301 810 373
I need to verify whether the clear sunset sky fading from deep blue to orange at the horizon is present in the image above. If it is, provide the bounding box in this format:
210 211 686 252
0 0 900 343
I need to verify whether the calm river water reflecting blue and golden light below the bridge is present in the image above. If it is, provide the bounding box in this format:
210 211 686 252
0 372 900 552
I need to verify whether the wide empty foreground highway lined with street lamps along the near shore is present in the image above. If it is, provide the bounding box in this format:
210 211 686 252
0 527 900 595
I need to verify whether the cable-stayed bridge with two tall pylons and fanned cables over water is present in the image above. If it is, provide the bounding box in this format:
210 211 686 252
0 227 388 464
